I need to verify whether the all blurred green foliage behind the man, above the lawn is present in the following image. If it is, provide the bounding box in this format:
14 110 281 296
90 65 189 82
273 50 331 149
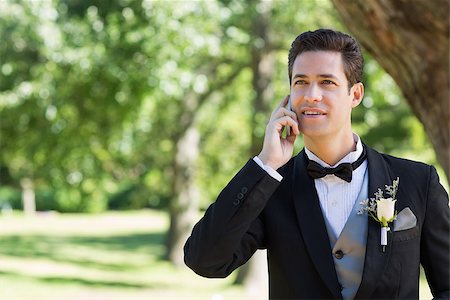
0 0 442 212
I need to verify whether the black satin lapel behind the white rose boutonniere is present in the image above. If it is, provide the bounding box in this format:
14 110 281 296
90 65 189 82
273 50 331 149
355 146 393 299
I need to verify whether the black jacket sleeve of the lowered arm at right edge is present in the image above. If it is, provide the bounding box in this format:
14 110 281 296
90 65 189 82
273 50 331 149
421 167 450 299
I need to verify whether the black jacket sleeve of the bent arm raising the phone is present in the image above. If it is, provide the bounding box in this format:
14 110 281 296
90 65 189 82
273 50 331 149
184 159 280 278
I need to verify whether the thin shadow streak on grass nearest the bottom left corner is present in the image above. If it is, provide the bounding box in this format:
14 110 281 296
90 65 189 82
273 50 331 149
0 271 159 289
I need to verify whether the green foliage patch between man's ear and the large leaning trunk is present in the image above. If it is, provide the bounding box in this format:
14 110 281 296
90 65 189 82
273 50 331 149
353 55 437 164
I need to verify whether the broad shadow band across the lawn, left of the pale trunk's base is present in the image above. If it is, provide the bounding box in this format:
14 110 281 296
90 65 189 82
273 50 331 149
0 232 164 271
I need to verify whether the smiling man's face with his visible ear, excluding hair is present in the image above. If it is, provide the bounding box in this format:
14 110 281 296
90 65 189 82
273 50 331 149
290 51 363 138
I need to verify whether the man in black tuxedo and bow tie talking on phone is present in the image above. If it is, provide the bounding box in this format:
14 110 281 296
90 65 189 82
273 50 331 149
185 29 450 299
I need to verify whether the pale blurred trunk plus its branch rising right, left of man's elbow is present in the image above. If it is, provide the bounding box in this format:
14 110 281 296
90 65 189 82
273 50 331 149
166 62 242 266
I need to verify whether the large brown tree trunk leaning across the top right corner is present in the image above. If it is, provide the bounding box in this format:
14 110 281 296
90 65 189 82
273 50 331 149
332 0 450 183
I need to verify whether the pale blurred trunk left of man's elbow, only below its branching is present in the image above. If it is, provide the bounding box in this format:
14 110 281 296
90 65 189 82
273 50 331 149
167 126 200 266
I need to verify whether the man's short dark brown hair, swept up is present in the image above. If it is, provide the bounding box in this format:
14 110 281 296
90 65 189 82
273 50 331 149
288 29 364 90
